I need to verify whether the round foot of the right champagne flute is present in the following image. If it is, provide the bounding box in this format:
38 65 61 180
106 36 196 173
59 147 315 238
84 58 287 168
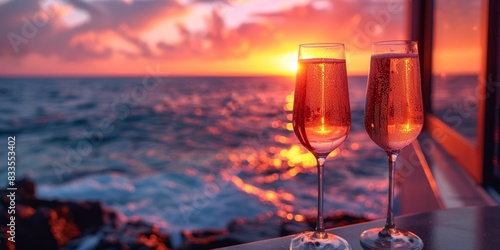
360 227 424 250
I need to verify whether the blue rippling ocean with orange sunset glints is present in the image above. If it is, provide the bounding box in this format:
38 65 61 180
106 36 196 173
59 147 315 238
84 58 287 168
0 76 476 243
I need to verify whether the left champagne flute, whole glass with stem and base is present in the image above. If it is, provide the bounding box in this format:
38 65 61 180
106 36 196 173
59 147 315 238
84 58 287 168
290 43 351 249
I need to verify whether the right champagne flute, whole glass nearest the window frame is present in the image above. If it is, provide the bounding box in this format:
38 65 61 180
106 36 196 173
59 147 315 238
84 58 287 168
360 41 424 249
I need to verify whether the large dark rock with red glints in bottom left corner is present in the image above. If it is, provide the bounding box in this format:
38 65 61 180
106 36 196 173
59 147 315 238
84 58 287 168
0 179 172 250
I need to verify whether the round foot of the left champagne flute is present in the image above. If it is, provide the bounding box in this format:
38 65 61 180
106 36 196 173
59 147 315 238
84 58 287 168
290 232 351 250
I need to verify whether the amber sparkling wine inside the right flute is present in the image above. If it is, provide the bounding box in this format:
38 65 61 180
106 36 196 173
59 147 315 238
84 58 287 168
365 54 424 152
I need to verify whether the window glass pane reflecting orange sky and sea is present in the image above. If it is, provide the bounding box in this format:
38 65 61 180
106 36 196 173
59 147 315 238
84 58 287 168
431 0 482 144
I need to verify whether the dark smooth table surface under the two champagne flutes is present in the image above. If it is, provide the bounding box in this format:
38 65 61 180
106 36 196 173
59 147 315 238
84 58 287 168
217 206 500 250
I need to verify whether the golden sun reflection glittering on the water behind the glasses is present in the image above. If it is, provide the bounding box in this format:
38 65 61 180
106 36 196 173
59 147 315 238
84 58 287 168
219 89 360 222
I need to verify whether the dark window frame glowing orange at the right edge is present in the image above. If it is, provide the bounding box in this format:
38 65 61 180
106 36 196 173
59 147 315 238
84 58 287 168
409 0 500 192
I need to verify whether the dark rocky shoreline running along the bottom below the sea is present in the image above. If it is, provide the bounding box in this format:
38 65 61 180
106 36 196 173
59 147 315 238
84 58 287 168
0 179 368 250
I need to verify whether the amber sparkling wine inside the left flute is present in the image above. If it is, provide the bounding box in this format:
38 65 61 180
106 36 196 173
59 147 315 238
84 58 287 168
293 59 351 157
